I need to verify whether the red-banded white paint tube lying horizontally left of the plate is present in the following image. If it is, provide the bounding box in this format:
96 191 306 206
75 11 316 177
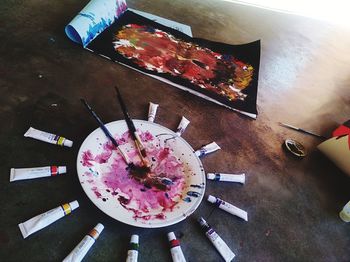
10 166 67 182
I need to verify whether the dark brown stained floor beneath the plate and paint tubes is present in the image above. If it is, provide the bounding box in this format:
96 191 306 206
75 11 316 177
0 0 350 261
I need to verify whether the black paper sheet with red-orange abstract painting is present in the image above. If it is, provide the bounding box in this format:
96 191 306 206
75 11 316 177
67 0 260 118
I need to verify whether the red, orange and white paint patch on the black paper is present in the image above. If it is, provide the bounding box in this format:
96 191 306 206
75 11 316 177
113 24 254 101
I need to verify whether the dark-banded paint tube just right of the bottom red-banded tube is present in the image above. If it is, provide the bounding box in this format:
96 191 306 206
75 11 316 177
198 217 236 262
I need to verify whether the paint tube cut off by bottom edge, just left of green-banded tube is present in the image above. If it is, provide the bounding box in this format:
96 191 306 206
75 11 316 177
63 223 104 262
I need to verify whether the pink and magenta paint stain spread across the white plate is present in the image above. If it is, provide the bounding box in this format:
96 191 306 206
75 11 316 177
81 132 190 220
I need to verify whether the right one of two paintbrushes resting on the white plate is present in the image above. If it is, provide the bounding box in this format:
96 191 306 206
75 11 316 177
115 86 148 165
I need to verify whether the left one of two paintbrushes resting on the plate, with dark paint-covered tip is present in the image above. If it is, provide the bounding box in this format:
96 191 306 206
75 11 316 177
80 98 150 179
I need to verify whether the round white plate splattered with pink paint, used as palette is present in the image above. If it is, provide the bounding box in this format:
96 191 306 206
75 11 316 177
77 120 205 228
